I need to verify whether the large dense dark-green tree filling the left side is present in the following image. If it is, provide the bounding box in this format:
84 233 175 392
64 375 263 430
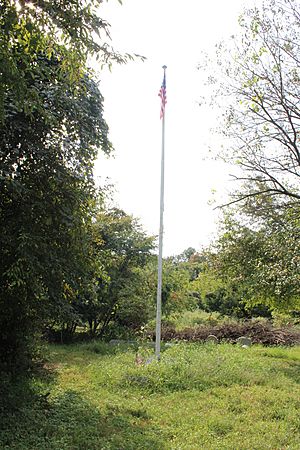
0 0 125 374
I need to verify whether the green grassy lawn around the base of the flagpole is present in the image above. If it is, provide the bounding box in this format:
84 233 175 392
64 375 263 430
0 343 300 450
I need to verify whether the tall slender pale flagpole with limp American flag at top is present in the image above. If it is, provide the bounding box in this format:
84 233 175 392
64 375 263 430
155 66 167 360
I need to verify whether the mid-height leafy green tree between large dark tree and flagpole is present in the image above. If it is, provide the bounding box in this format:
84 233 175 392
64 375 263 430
79 208 154 336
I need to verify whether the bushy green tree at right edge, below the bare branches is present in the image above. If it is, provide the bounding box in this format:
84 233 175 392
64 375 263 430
214 210 300 311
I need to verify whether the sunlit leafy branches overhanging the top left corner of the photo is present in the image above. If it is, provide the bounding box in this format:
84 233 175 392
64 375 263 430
0 0 138 121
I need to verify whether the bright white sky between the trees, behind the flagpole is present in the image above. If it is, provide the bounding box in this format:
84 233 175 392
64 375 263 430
95 0 253 256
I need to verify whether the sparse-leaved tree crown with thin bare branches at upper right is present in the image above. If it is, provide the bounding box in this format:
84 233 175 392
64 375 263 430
206 0 300 207
